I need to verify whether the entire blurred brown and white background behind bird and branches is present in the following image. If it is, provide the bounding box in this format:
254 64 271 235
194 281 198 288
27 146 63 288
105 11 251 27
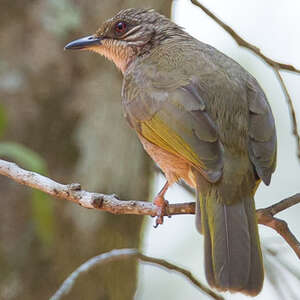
0 0 300 300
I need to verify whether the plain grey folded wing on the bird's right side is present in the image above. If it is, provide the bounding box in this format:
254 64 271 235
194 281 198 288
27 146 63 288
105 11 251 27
247 82 277 185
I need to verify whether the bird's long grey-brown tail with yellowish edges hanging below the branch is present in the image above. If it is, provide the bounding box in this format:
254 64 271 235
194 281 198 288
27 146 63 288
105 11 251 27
197 176 264 296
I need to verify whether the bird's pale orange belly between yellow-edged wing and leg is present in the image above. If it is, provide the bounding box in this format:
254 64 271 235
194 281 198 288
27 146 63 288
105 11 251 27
138 135 196 187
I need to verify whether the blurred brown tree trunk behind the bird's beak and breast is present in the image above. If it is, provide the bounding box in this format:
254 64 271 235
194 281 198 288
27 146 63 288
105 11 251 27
0 0 171 300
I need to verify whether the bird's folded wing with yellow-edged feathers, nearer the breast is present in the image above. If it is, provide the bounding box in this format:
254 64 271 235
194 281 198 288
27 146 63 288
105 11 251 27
123 81 223 182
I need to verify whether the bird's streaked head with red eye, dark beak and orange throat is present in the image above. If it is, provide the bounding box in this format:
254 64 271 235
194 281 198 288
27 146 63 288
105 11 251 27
65 8 183 73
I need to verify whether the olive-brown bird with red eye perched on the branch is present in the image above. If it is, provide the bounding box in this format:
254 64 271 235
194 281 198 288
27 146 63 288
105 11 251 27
65 8 277 296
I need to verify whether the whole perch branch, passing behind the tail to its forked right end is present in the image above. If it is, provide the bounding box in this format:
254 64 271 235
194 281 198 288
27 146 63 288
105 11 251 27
0 159 300 259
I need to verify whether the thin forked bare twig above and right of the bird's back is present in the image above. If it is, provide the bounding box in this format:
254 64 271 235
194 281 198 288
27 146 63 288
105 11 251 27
191 0 300 159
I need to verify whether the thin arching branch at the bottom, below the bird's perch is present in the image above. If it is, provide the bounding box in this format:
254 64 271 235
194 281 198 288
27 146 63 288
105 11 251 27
50 249 224 300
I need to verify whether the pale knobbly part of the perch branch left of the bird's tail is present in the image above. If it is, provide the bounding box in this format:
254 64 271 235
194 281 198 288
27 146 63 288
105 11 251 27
0 159 195 217
